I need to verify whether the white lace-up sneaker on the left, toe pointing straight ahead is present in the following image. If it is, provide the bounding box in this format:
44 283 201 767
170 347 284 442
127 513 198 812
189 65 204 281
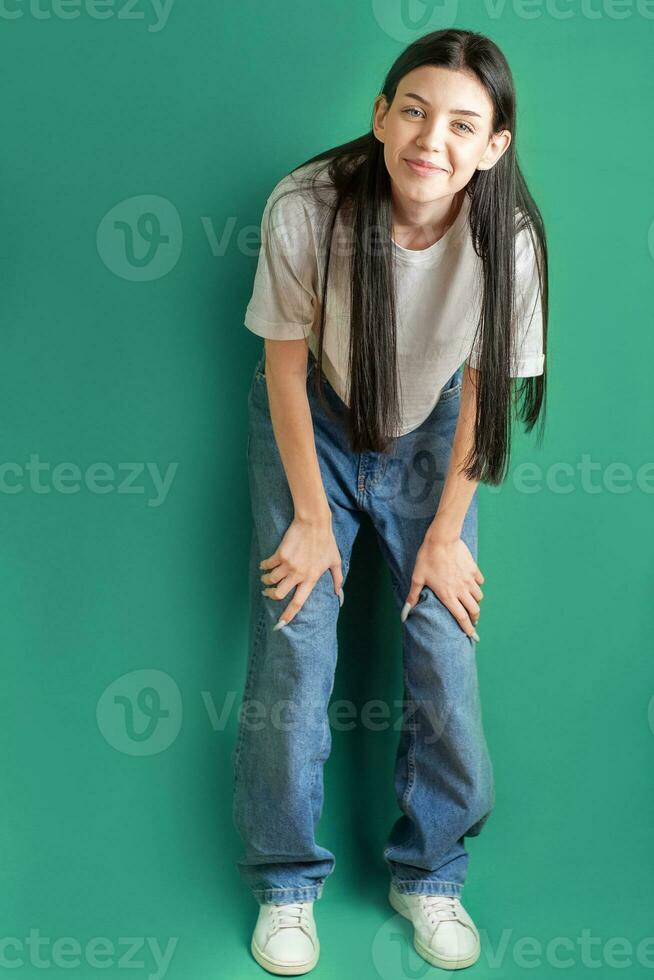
250 902 320 976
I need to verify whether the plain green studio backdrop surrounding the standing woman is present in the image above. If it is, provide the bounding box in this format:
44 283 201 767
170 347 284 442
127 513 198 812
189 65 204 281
0 0 654 980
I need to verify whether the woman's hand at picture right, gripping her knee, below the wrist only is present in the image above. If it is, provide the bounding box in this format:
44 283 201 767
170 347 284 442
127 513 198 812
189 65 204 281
400 530 484 641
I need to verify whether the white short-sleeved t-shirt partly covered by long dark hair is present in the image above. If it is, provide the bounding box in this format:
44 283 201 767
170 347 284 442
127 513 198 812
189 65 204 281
245 161 544 435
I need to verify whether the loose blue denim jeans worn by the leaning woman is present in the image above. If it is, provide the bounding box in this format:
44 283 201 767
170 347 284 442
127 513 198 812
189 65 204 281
232 351 494 904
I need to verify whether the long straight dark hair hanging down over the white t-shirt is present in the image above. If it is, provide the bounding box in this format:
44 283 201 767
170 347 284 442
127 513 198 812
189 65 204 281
266 29 548 484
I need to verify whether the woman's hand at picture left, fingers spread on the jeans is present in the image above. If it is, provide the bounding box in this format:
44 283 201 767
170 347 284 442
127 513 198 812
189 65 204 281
259 517 344 629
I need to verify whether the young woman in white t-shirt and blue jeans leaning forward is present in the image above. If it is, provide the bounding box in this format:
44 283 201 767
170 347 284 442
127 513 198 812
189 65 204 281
233 30 547 975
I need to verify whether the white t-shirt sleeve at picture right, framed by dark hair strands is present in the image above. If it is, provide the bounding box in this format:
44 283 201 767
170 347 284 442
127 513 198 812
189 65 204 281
468 225 545 378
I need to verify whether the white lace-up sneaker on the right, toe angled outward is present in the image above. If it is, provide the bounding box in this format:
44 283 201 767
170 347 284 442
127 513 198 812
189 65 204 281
388 882 480 970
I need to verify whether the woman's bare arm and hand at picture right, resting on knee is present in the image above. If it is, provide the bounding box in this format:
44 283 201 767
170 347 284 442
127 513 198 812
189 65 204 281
400 364 484 641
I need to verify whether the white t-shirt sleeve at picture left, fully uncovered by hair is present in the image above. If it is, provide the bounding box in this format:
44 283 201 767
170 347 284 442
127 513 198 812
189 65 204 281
245 182 317 340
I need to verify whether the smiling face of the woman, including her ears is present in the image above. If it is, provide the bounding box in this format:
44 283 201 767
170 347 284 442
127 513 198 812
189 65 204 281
373 65 511 203
